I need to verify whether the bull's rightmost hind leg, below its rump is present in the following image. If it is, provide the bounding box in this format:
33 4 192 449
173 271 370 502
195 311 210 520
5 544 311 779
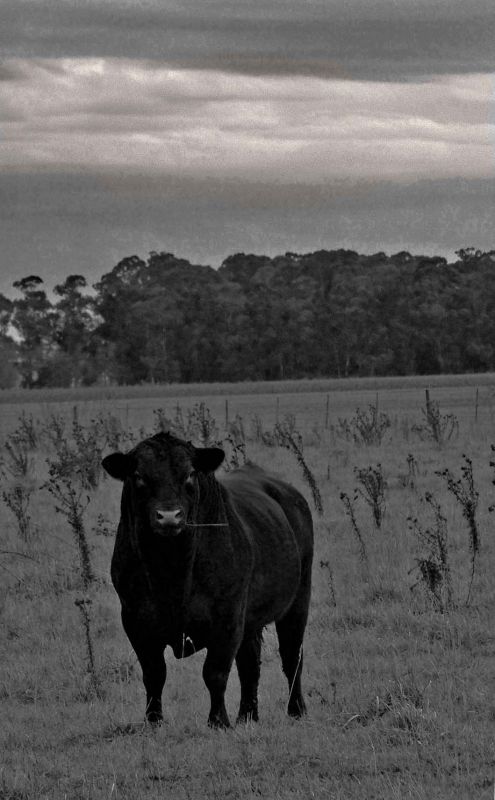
275 591 309 717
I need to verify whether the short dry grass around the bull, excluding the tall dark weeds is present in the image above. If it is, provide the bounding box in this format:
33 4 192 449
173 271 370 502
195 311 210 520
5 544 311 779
0 381 495 800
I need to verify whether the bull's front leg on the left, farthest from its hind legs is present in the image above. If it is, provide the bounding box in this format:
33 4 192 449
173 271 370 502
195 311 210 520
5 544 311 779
122 612 167 724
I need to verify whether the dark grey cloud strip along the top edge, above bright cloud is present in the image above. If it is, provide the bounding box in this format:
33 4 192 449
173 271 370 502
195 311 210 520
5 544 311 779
0 0 495 80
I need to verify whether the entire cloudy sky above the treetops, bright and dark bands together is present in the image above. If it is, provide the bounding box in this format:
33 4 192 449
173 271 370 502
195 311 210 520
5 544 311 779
0 0 495 296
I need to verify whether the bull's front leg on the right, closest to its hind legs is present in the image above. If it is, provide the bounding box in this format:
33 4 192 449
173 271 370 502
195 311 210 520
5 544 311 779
203 624 242 728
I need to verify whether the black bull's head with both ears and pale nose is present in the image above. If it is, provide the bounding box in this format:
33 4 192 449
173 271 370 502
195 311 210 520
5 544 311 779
102 433 225 536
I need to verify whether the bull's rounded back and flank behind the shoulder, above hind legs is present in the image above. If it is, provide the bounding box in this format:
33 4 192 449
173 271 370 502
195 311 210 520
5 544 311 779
221 466 313 626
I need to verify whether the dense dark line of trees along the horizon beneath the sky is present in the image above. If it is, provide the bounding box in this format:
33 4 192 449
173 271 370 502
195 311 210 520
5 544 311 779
0 248 495 388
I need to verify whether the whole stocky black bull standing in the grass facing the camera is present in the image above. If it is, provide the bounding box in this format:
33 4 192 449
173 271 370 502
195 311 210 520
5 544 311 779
103 433 313 727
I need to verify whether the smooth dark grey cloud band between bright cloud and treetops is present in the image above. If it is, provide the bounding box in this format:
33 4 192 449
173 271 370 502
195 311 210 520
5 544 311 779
0 172 495 293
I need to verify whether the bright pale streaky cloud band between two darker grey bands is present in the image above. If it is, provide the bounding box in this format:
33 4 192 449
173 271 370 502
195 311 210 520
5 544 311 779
0 59 495 183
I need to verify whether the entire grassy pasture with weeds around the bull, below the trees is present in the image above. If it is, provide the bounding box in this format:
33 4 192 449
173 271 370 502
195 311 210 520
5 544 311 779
0 375 495 800
